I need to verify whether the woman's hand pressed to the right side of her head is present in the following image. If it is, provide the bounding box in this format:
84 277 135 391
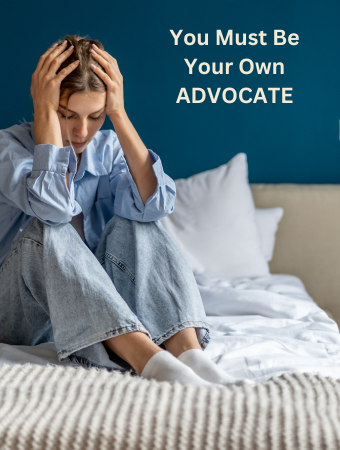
91 44 125 118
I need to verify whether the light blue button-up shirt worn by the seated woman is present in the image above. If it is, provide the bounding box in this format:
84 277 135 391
0 122 176 265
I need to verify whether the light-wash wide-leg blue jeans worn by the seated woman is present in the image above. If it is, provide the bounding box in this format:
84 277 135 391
0 215 210 375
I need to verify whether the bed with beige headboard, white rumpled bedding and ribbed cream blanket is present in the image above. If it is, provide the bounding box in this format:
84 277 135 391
0 154 340 450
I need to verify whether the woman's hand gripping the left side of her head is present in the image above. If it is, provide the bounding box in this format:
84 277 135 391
31 40 79 112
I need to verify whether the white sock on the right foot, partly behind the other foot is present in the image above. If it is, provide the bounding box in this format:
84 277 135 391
178 348 255 386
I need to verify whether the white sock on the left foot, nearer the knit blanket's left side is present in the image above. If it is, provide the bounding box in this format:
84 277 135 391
141 350 211 386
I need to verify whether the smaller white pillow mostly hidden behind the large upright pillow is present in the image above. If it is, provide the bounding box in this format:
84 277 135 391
255 207 283 261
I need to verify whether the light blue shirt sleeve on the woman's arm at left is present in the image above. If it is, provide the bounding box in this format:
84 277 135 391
0 138 81 225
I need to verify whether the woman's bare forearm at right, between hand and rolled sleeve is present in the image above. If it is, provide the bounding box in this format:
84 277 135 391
110 111 157 205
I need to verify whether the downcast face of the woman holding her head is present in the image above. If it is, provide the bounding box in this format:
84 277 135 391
58 91 106 153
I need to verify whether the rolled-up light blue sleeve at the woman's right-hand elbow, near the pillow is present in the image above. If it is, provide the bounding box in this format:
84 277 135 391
110 147 176 222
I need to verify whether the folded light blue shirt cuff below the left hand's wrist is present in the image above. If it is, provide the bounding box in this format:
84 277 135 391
32 144 77 175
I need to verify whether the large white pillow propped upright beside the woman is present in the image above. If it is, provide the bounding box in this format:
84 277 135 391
160 153 269 278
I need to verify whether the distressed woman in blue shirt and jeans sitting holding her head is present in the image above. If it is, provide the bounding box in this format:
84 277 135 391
0 35 244 385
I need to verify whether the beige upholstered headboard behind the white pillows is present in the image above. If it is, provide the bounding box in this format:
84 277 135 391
251 184 340 326
